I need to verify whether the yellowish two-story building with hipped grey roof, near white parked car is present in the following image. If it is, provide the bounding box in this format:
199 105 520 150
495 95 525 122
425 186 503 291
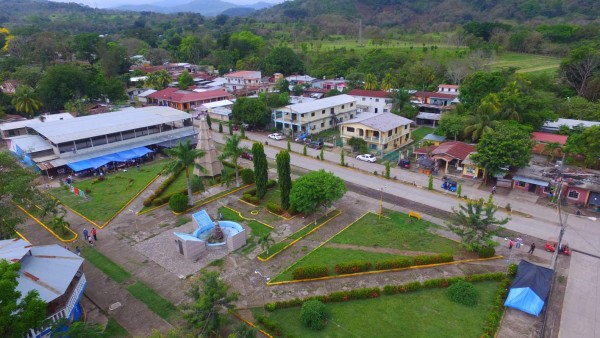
340 113 412 153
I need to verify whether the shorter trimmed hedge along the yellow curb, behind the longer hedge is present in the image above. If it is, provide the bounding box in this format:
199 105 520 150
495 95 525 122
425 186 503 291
293 254 454 279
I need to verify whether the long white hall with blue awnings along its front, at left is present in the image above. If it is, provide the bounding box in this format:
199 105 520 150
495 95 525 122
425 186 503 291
0 106 196 175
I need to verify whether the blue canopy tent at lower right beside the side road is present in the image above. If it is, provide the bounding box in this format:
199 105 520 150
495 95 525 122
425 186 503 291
504 261 553 316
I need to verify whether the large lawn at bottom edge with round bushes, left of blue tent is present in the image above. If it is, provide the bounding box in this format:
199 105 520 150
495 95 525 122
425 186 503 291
257 282 498 338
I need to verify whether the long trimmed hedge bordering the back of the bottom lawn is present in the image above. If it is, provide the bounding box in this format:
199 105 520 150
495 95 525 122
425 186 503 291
265 272 506 312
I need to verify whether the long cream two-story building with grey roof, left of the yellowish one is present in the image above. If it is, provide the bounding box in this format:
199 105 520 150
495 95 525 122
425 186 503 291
273 94 357 133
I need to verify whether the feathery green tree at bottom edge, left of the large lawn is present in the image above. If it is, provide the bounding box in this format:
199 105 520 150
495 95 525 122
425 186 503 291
185 270 237 337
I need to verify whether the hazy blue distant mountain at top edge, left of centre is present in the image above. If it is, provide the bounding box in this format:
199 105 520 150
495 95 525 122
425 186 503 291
115 0 273 16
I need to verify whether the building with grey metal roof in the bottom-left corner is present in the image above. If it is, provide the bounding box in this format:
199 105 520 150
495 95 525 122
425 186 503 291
0 239 87 338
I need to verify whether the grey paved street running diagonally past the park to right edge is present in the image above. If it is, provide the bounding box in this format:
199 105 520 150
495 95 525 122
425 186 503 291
213 127 600 337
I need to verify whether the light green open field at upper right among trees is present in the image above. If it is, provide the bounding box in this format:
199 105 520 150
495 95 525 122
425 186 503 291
490 52 561 73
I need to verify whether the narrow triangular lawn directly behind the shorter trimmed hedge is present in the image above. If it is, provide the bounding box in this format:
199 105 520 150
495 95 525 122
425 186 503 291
273 246 404 282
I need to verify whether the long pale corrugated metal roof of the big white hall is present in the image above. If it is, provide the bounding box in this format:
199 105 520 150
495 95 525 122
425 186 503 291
31 106 191 144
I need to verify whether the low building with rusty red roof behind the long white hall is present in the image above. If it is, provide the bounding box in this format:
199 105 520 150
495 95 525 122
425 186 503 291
146 88 233 111
